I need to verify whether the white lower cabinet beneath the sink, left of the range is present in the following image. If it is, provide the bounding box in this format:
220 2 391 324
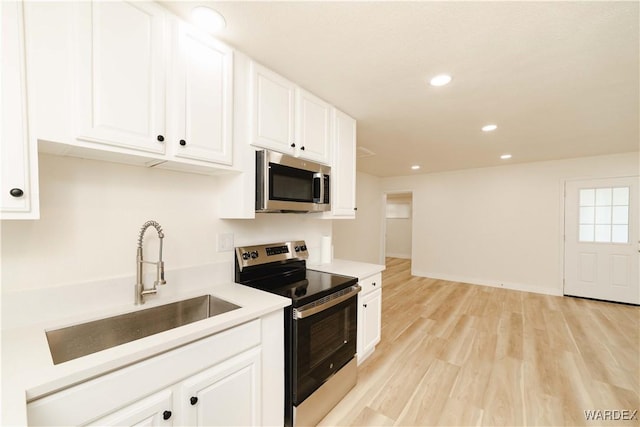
27 316 284 426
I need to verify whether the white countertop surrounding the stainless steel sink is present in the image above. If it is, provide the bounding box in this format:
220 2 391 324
1 283 291 425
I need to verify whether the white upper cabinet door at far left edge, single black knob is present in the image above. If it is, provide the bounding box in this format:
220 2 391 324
0 1 38 219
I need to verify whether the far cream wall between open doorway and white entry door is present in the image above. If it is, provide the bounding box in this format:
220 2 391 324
382 152 640 295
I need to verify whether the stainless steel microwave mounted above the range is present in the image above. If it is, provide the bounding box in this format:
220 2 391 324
256 150 331 212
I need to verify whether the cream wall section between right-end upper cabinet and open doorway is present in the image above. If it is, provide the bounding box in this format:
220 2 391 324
333 172 384 264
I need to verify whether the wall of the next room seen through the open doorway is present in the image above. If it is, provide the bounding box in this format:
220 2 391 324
385 193 413 259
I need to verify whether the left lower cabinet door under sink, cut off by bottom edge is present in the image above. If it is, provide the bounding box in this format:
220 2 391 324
88 389 176 426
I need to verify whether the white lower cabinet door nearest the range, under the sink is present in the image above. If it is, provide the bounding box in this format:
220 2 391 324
180 347 262 426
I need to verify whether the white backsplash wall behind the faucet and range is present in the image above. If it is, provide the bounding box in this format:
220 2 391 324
1 154 331 293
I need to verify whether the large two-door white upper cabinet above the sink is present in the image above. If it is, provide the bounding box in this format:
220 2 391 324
25 0 233 174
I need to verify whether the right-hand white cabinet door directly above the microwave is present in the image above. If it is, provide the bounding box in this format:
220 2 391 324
296 89 333 164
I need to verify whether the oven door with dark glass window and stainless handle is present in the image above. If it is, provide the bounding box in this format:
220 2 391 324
292 285 360 406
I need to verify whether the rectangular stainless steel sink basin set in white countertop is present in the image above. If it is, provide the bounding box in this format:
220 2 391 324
46 295 240 365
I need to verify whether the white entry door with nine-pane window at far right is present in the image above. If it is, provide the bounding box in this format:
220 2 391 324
564 177 640 304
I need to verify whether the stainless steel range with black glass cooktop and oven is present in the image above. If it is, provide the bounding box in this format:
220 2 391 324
235 241 360 426
